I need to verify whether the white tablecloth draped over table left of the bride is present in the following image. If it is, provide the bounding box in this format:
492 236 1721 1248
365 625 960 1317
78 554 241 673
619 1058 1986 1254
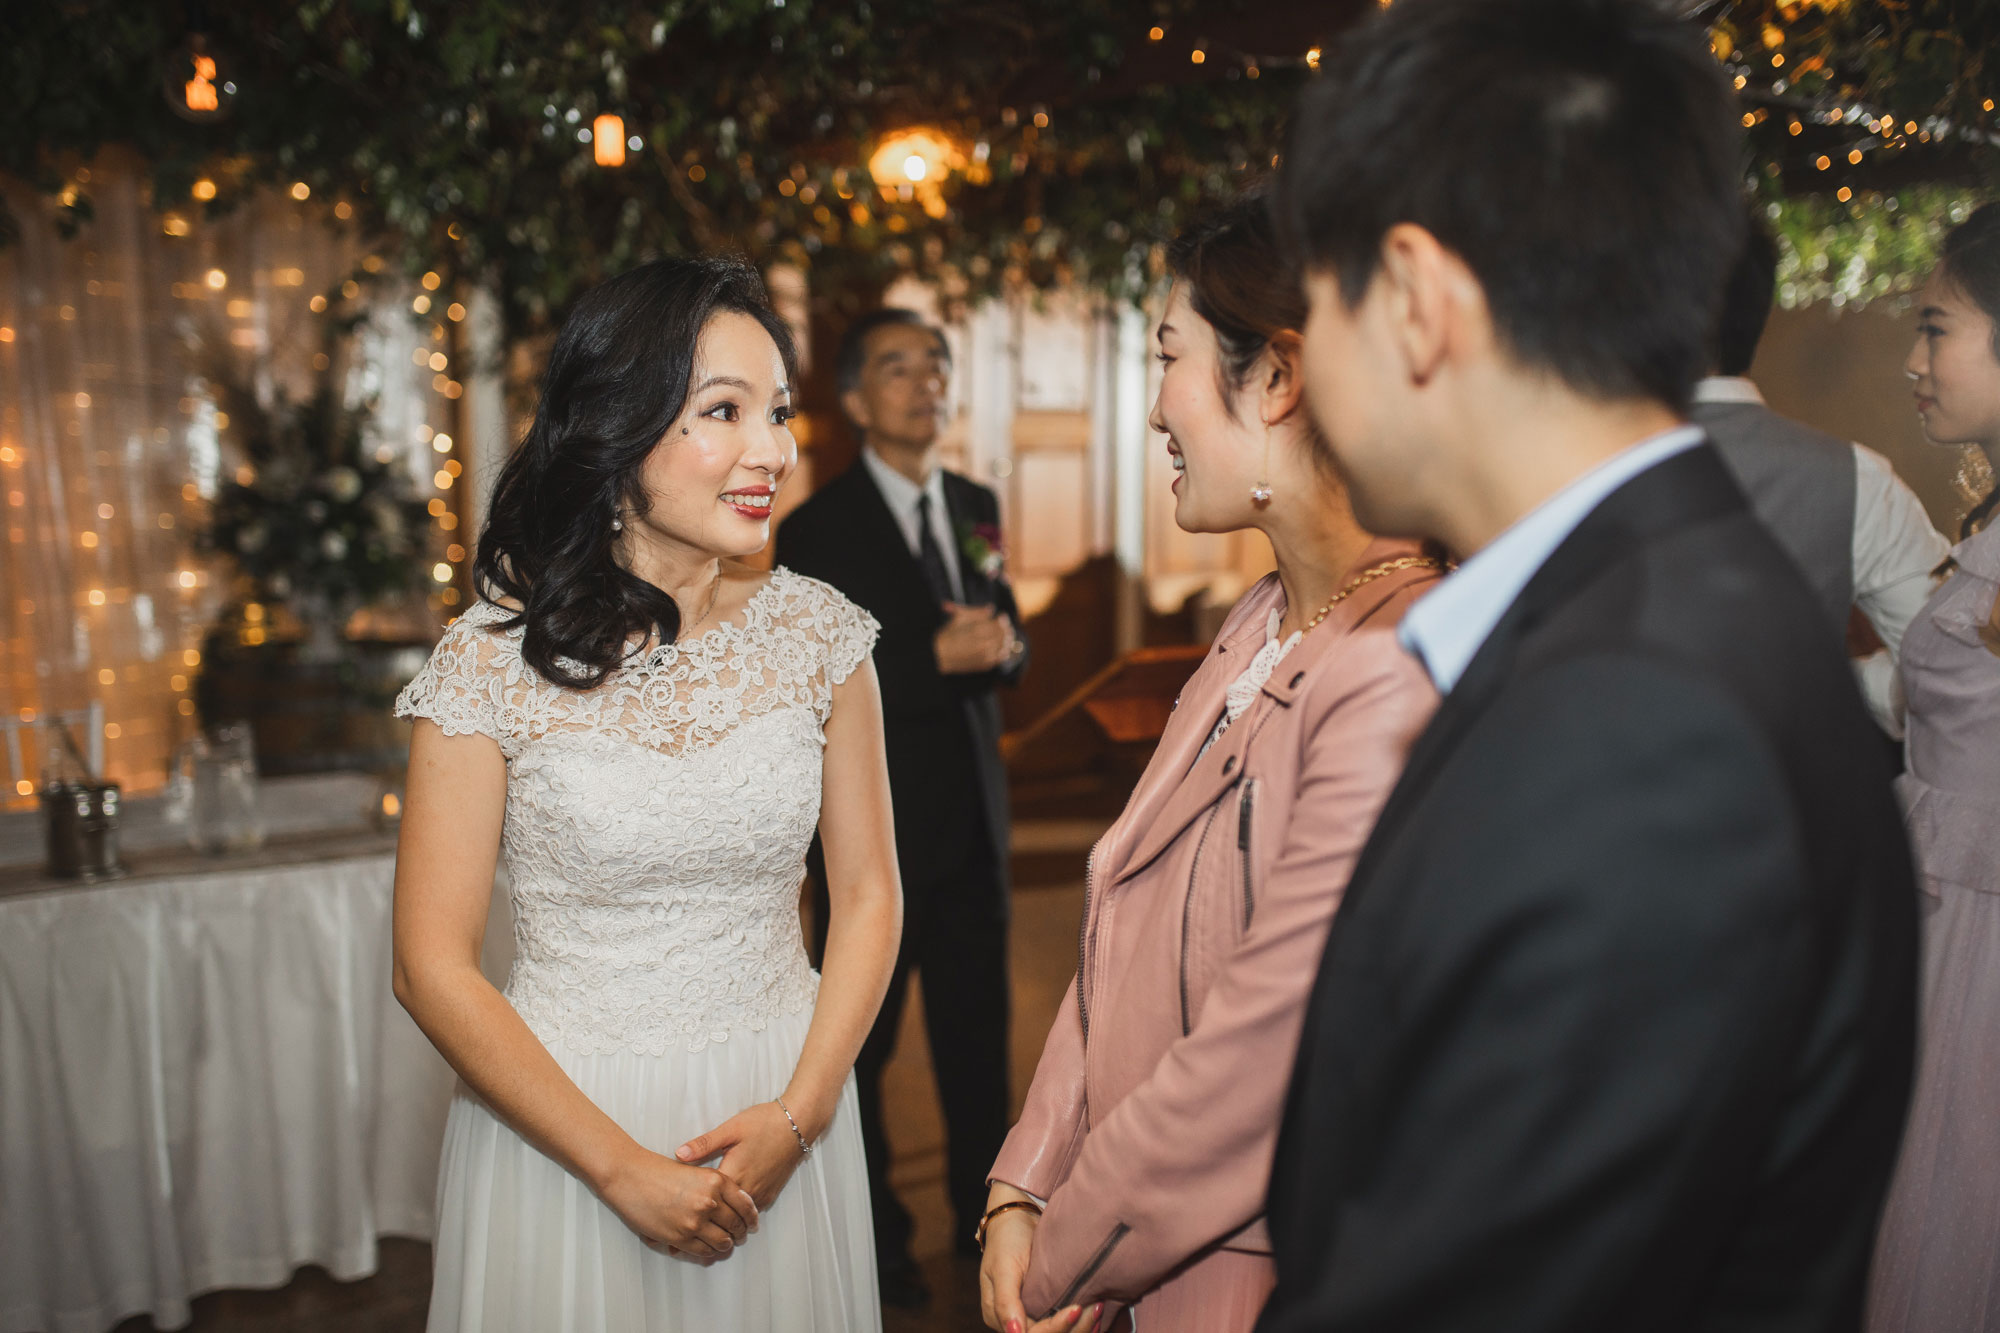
0 839 506 1333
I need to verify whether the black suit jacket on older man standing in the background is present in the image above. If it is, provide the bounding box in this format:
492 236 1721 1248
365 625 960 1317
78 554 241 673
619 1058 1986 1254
778 462 1026 892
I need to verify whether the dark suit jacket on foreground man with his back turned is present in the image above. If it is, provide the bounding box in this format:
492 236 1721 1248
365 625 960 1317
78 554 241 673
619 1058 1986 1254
1258 446 1916 1333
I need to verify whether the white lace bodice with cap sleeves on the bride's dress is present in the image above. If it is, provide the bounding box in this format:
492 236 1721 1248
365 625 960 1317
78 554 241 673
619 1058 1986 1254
396 568 878 1055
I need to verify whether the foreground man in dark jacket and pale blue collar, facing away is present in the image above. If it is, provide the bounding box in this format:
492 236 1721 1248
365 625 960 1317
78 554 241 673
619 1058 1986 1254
1258 0 1916 1333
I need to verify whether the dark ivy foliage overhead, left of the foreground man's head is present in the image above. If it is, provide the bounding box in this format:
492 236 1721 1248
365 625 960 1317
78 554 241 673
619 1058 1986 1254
0 0 1306 334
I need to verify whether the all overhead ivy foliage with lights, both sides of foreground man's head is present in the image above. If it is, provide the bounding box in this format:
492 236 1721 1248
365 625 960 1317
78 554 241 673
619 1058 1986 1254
15 0 2000 336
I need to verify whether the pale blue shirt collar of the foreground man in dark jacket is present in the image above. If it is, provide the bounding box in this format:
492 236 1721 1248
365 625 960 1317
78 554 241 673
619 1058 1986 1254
1396 426 1706 695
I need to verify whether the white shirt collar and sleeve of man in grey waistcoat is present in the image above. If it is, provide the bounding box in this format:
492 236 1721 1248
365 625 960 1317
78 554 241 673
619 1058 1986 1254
1694 374 1952 737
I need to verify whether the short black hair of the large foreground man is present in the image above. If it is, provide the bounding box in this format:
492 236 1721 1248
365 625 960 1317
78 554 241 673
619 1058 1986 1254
1276 0 1744 410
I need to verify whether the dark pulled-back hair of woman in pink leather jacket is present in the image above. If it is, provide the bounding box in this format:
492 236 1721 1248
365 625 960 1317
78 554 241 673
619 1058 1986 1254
1166 184 1338 476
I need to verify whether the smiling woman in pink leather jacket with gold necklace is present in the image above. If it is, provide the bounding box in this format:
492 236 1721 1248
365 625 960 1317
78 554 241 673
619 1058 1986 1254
980 198 1442 1333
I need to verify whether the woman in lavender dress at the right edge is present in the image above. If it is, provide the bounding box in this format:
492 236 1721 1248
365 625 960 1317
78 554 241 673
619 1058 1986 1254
1868 204 2000 1333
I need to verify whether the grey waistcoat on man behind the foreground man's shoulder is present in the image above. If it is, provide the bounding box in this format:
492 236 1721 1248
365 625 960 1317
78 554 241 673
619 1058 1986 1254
1690 402 1854 628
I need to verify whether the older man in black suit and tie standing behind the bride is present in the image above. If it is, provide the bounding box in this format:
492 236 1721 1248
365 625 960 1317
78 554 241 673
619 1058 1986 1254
778 310 1026 1305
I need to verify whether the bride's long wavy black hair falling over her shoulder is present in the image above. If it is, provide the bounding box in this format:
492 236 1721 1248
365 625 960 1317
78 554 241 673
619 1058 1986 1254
472 258 798 689
